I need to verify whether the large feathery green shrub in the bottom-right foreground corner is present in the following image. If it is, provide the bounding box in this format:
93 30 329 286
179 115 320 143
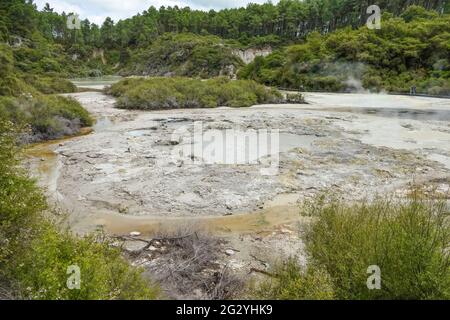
307 200 450 299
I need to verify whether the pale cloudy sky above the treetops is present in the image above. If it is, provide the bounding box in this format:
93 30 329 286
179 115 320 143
34 0 278 24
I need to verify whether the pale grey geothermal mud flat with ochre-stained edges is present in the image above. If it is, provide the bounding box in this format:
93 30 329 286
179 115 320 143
25 92 450 294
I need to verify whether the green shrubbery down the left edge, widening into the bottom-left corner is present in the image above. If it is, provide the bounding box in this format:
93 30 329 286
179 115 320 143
0 118 158 300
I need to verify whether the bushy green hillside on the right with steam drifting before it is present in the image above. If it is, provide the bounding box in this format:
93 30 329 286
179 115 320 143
240 6 450 95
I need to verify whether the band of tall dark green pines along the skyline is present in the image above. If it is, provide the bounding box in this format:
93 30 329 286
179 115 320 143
0 0 450 47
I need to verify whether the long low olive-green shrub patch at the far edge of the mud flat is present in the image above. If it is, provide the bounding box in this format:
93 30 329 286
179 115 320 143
107 77 282 110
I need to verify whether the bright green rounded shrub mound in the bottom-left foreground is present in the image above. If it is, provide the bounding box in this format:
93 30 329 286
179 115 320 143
13 225 158 300
